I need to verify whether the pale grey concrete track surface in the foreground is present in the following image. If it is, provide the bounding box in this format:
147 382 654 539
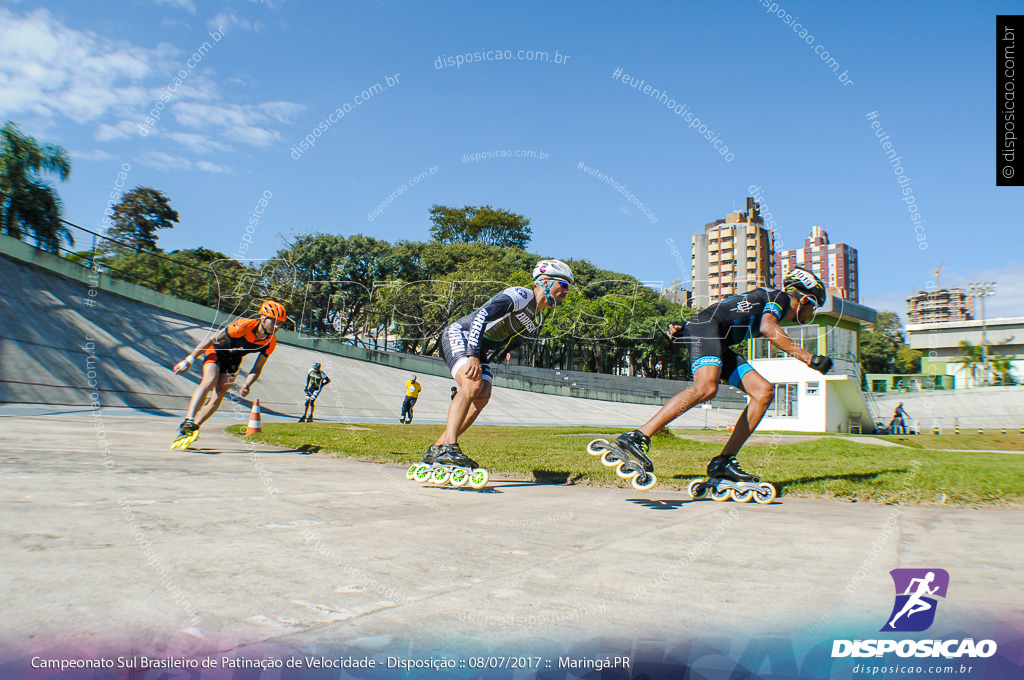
0 406 1024 654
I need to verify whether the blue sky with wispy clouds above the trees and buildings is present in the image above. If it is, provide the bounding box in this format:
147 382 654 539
0 0 1024 316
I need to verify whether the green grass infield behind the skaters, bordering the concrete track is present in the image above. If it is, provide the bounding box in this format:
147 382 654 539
228 423 1024 507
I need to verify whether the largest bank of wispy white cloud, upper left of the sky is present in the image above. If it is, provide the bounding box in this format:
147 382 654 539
0 6 306 157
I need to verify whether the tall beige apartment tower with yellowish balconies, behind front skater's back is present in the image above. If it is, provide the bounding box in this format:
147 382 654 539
690 198 775 307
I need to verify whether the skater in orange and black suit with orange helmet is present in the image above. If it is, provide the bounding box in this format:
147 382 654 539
171 300 288 449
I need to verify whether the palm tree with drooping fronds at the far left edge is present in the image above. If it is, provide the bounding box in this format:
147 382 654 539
0 121 75 253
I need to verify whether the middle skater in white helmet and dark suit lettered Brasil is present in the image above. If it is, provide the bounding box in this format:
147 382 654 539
423 260 573 468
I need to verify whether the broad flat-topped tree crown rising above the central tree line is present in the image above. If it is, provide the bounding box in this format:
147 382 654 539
430 205 531 250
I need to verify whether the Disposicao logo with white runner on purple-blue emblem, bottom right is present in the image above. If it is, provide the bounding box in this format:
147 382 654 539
831 569 996 658
